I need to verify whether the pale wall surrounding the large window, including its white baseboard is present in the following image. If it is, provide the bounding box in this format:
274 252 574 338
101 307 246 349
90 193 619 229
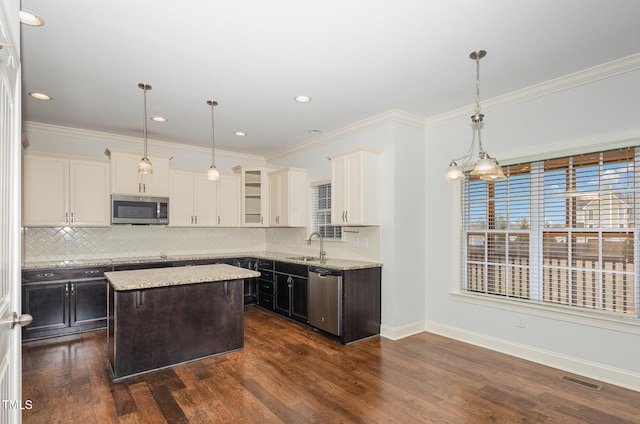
424 67 640 390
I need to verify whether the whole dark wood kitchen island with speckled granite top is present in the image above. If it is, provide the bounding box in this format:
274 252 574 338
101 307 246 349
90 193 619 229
104 264 260 381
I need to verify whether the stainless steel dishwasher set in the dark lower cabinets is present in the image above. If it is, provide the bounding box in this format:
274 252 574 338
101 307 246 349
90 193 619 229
308 266 342 336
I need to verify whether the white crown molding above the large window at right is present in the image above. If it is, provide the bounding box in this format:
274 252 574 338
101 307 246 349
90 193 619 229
426 53 640 128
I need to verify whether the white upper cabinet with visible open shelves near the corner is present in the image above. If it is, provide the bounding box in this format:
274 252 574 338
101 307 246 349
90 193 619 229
233 166 277 227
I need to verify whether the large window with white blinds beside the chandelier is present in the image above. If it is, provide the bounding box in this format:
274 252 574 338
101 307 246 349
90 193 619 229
462 148 640 317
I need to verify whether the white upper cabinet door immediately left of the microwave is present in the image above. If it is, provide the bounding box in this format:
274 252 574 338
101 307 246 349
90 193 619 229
69 159 111 226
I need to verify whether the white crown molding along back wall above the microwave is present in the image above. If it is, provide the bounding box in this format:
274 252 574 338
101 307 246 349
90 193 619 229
22 121 265 161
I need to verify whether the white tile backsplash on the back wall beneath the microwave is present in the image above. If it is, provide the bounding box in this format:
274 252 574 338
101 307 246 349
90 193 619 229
22 225 266 263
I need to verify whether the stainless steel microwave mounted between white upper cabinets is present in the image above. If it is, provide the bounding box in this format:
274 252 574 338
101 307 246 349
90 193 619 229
111 194 169 225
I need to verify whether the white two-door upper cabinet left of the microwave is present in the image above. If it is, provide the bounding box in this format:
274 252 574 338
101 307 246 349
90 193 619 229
22 153 111 227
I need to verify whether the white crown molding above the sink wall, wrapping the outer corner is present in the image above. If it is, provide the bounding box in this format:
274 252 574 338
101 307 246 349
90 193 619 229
266 109 426 161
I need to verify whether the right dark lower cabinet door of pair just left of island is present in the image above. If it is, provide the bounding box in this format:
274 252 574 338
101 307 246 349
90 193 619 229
69 278 107 328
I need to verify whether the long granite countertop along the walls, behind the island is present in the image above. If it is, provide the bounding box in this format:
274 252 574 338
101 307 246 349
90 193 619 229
22 251 382 271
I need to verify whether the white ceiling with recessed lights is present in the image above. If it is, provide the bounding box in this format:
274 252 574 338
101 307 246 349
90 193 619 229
21 0 640 156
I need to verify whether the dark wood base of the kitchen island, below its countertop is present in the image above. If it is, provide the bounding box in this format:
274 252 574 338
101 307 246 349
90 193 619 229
107 280 244 380
